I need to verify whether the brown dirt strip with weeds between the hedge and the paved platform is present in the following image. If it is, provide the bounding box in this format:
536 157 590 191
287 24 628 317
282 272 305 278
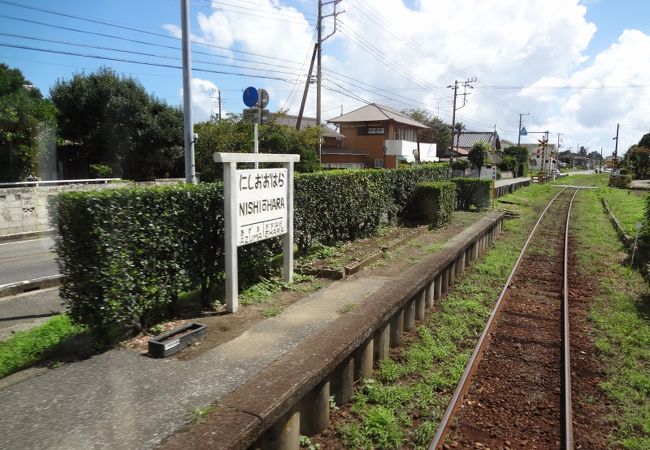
123 211 487 359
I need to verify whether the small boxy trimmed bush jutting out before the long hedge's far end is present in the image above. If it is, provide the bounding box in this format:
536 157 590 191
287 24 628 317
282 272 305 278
410 181 456 227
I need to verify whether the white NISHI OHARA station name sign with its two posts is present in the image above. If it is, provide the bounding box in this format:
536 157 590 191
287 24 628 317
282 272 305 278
213 153 300 313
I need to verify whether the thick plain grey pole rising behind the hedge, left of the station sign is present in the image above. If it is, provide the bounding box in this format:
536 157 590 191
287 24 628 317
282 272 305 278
181 0 196 184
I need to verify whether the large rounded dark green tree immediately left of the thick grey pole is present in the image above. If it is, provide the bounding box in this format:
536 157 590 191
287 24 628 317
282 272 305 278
50 67 183 180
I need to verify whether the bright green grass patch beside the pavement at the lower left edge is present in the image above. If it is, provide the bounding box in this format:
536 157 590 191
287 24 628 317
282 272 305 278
0 314 85 378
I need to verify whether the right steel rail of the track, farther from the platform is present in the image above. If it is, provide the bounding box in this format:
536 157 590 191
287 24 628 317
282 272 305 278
562 188 580 450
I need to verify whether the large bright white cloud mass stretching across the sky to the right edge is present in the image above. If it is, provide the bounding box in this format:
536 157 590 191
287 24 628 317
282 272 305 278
181 0 650 154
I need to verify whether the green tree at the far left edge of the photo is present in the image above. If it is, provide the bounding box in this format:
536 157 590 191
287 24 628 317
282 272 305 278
0 64 56 182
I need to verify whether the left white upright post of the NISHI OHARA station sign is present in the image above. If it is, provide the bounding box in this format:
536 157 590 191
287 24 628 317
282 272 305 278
223 161 239 313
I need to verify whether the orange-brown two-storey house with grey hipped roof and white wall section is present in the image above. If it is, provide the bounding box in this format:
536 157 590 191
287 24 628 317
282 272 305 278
321 103 438 169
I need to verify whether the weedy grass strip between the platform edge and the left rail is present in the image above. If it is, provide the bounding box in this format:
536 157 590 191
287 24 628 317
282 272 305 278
330 181 557 449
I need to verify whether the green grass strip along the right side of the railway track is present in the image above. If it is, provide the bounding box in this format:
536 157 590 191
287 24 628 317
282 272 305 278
575 191 650 449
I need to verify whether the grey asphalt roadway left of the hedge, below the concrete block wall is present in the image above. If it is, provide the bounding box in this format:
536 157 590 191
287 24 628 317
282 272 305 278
0 237 59 285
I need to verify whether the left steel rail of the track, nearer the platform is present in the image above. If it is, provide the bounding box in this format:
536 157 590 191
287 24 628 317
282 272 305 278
429 186 575 450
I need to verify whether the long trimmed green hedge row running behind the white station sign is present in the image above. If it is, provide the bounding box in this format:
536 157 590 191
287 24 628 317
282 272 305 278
50 165 448 329
